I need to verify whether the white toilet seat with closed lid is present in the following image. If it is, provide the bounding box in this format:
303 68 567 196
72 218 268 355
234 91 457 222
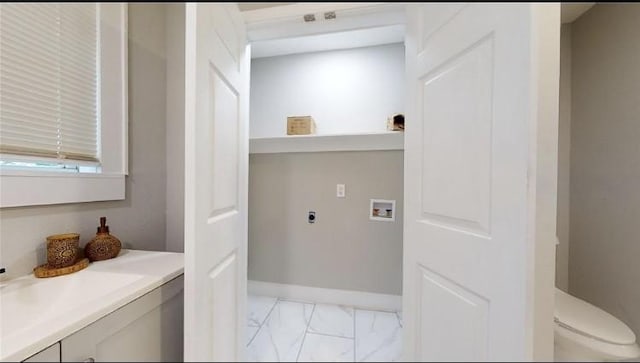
555 288 636 345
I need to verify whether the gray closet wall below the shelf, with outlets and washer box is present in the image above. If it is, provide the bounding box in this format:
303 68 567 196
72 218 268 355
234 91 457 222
249 151 403 295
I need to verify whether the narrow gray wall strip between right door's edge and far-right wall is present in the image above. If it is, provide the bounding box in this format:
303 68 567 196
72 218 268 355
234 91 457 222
556 24 571 291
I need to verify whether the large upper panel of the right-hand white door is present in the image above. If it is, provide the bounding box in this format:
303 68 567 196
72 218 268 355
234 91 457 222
422 37 493 236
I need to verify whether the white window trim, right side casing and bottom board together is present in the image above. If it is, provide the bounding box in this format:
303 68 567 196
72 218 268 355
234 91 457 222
0 3 128 208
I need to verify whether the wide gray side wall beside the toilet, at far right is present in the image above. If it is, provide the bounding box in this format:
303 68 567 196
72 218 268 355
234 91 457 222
569 4 640 336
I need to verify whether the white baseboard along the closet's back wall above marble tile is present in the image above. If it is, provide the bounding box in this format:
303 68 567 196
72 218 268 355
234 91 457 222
247 280 402 311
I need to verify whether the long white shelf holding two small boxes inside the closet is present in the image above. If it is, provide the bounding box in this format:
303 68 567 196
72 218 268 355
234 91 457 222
249 131 404 154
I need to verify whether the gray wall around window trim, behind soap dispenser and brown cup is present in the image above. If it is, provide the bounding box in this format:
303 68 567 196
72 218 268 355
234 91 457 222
0 4 166 279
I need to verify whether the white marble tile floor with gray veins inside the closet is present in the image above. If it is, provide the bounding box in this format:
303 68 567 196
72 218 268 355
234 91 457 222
247 295 402 362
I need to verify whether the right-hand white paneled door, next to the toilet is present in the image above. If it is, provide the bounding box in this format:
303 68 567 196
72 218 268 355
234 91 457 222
403 3 560 361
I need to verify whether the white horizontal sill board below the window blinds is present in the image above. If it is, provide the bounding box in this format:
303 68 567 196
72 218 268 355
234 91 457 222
0 171 125 208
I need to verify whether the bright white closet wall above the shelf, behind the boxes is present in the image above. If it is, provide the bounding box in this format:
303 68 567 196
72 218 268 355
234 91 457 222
250 44 405 137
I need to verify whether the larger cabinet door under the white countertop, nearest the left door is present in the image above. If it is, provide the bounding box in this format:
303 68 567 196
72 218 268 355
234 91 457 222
61 277 184 362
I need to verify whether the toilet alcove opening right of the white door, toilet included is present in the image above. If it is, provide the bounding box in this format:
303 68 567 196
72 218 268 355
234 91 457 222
555 3 640 361
